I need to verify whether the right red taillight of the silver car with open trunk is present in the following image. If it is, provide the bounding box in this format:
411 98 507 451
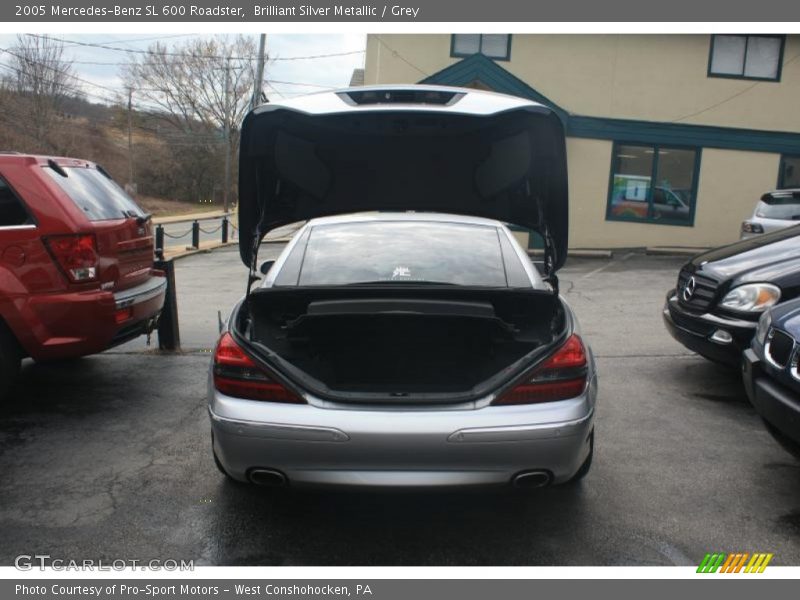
492 334 588 405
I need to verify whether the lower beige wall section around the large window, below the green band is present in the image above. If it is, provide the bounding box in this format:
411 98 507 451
567 138 780 248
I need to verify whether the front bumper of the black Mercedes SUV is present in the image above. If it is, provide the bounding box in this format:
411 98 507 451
662 290 757 367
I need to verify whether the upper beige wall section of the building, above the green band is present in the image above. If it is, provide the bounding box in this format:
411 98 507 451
365 34 800 132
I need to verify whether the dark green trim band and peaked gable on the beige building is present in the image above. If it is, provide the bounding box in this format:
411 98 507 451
420 54 800 155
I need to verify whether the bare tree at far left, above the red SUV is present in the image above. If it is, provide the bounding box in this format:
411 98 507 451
5 35 77 151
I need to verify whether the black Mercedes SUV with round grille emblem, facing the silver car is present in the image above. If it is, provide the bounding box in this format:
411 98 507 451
663 226 800 366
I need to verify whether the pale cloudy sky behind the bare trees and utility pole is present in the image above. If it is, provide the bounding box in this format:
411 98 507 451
0 33 366 108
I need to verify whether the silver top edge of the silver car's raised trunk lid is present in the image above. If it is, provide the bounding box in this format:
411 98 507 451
253 85 552 115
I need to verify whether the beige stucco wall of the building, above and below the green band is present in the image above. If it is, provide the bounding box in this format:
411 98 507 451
365 34 800 248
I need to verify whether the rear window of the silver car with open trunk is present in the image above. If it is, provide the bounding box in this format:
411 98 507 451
275 221 530 287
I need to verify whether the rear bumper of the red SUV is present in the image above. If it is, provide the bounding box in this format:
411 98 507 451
15 272 167 360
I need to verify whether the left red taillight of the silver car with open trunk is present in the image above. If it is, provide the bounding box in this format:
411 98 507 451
214 332 305 404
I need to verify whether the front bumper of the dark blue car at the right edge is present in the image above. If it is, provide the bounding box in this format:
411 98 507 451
742 348 800 444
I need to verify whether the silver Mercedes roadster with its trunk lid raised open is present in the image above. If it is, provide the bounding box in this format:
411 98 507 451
208 86 597 487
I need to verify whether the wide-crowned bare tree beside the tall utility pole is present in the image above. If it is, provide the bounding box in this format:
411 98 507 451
124 35 257 209
